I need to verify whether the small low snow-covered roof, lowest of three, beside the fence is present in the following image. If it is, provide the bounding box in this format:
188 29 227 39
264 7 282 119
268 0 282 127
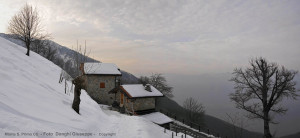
141 112 173 125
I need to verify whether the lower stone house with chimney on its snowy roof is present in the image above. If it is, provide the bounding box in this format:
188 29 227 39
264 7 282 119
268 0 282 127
109 84 163 115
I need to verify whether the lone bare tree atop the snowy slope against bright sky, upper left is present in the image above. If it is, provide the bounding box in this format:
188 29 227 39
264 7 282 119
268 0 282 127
8 4 49 56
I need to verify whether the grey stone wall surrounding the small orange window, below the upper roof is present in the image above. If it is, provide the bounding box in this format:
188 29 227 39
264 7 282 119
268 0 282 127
87 75 119 105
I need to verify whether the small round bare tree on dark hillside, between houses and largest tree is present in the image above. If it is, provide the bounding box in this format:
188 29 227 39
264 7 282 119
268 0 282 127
183 97 205 122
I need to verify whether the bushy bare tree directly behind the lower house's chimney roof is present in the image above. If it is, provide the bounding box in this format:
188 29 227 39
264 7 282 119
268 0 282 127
140 73 173 98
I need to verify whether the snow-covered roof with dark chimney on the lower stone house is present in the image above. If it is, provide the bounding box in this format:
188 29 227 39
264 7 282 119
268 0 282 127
121 84 163 98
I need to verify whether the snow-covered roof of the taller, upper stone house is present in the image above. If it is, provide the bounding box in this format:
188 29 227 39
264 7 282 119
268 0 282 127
84 63 121 75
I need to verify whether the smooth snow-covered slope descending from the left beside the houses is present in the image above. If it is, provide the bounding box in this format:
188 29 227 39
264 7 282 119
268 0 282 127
0 37 192 138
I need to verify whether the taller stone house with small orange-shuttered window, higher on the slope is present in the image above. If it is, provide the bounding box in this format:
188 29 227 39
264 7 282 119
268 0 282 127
80 63 122 105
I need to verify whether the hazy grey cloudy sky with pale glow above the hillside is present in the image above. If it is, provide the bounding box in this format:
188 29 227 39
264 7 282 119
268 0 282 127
0 0 300 136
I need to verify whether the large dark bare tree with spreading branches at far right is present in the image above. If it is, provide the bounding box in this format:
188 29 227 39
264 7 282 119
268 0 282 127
230 57 298 138
